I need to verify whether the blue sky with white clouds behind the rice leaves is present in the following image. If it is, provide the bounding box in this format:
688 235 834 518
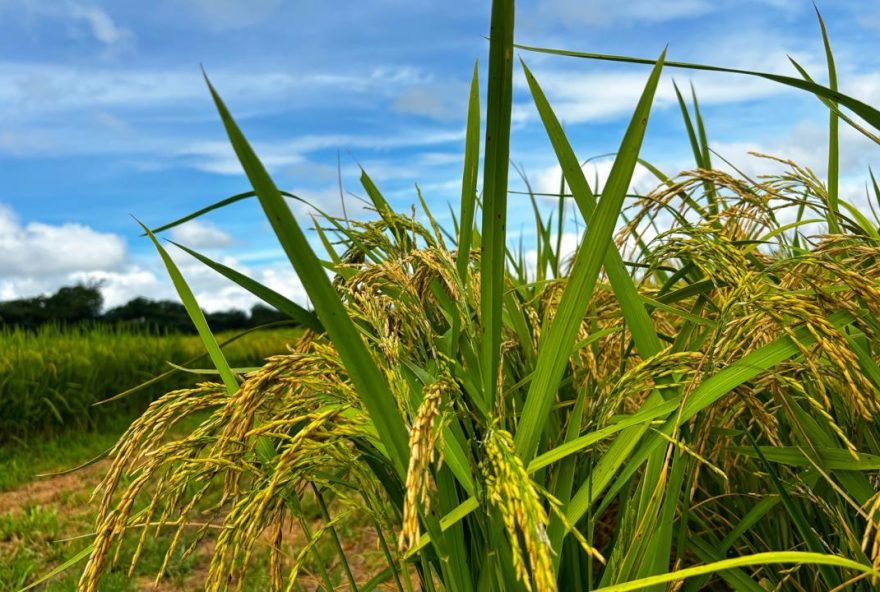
0 0 880 310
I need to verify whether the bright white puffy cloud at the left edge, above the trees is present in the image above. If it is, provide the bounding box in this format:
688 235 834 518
0 204 126 277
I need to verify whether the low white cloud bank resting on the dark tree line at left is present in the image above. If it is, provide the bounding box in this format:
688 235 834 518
0 204 308 312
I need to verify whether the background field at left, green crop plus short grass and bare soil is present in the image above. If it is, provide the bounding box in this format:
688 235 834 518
0 325 299 592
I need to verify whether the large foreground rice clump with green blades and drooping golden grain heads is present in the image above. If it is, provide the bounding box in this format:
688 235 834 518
63 0 880 592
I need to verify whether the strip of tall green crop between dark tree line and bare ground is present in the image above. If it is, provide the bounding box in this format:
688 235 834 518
0 325 296 444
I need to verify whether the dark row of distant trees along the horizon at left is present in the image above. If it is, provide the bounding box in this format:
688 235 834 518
0 285 289 333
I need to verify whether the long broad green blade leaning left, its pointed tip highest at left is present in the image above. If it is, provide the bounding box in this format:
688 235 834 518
205 76 409 477
